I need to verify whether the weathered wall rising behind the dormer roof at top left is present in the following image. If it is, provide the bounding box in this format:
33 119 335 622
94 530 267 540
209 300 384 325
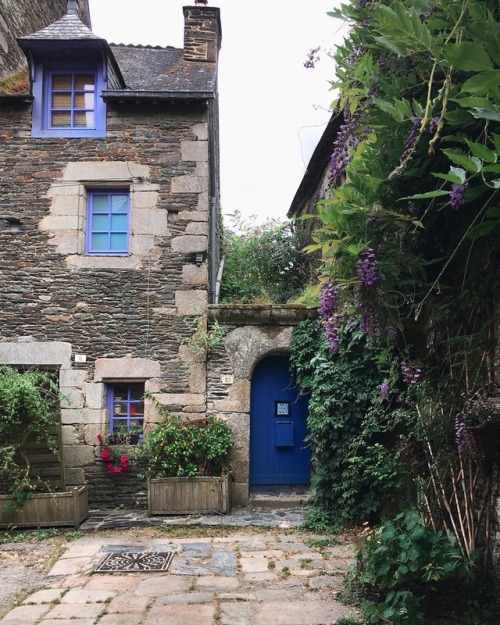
0 0 90 80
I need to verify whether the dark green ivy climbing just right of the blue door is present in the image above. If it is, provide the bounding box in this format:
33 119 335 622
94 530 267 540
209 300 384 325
292 321 401 531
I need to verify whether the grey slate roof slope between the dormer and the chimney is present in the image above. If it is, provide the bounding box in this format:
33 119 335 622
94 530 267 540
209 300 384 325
110 44 217 93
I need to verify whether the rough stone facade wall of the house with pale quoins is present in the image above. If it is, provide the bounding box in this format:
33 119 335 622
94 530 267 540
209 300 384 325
0 98 209 503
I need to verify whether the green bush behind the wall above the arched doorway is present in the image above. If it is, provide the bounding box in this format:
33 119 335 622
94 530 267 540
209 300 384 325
220 214 311 304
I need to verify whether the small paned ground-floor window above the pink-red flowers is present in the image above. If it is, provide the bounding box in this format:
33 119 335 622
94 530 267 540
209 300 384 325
108 382 144 433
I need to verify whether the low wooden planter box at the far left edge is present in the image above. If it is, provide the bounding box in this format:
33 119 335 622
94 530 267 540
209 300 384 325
0 486 89 529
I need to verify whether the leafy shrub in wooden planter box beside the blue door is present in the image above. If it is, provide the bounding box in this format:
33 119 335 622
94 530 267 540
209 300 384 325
141 395 233 515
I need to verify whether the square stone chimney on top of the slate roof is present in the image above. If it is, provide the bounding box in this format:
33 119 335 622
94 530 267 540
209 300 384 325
183 5 222 63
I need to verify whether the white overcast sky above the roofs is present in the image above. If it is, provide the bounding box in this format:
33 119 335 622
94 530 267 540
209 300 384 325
90 0 347 222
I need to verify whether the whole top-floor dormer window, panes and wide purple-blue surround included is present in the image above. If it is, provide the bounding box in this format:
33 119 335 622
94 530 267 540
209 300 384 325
32 64 106 138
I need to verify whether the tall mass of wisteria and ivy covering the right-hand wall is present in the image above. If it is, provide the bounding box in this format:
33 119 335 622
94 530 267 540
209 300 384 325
294 0 500 623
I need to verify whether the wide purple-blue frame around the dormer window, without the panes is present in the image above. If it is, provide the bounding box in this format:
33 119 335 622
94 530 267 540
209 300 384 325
31 62 107 138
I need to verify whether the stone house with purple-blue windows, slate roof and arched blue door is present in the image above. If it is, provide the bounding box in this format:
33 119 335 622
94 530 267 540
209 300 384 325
0 0 310 507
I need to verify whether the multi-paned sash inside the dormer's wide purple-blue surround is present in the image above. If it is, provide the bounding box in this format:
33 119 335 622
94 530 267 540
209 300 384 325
47 72 96 129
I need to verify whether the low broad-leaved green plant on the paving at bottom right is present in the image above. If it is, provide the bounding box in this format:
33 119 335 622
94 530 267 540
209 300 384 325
356 509 470 625
